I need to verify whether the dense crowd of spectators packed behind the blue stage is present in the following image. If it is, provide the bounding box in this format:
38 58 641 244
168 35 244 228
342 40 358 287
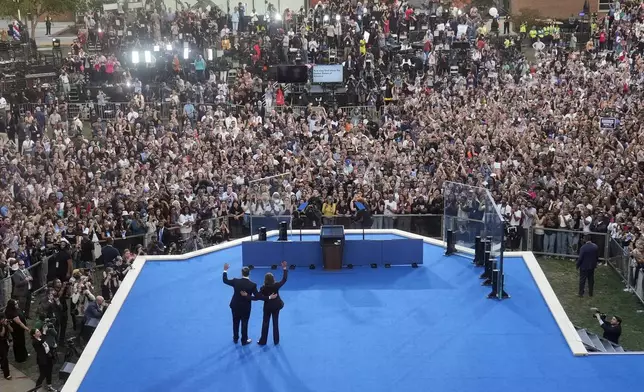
0 1 644 386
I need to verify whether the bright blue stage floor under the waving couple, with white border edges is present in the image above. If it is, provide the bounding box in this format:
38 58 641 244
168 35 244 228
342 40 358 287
63 231 644 392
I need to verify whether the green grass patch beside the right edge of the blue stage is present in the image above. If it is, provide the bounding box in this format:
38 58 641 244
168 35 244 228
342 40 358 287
539 258 644 351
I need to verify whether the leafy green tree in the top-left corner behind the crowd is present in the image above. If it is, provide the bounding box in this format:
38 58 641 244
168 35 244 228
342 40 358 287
0 0 80 38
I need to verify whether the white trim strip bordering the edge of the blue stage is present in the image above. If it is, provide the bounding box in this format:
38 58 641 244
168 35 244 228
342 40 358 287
61 229 588 392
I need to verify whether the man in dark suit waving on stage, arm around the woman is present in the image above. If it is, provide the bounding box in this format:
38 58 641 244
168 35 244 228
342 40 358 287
223 263 277 346
